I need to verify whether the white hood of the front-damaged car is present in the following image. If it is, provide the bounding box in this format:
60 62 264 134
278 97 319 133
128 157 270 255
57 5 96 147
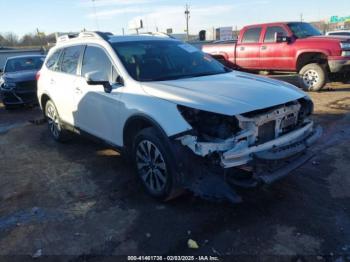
142 72 306 115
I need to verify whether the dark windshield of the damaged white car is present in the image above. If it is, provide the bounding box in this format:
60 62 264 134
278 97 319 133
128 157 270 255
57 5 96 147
112 40 231 82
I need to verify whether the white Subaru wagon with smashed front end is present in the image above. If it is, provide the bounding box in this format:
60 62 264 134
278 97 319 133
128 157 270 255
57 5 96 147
37 32 321 202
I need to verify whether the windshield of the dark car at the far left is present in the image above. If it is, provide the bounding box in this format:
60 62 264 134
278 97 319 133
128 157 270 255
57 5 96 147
4 56 45 73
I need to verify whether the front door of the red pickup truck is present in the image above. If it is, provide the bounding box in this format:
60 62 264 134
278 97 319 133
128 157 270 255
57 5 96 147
260 26 294 70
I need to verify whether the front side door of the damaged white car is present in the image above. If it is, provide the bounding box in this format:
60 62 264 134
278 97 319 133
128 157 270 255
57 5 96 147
74 45 121 144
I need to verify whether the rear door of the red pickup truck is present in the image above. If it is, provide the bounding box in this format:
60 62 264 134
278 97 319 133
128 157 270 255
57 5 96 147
236 27 262 69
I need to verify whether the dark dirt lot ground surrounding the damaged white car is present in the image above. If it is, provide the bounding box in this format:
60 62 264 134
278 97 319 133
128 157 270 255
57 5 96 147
0 79 350 261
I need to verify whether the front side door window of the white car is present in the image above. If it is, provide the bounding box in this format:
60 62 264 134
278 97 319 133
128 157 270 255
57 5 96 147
81 46 115 82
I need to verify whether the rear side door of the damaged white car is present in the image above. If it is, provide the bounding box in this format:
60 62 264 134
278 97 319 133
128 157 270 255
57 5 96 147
49 45 84 125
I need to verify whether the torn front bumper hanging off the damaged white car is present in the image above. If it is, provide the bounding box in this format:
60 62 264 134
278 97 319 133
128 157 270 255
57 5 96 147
177 122 322 203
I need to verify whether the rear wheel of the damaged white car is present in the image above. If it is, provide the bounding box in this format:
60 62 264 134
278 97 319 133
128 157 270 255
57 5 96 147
45 100 69 142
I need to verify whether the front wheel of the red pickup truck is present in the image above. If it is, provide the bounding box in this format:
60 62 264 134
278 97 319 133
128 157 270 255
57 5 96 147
299 63 327 91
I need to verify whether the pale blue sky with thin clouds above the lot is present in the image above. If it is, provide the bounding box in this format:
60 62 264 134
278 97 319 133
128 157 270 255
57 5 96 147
0 0 350 36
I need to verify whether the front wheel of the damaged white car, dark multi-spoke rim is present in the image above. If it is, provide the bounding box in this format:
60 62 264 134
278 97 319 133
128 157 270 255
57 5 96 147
131 127 176 200
